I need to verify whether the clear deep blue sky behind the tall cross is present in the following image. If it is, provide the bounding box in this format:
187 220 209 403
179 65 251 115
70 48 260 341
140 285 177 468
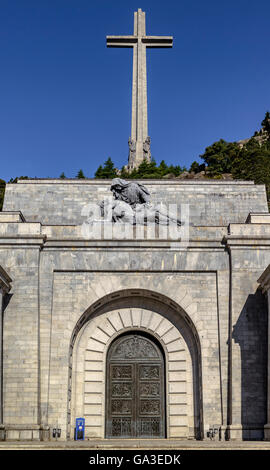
0 0 270 180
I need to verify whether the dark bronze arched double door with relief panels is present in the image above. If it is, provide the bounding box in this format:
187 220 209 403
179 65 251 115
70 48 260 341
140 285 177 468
106 334 165 438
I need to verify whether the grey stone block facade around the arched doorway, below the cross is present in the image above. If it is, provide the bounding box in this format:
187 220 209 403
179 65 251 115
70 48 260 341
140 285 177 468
0 180 270 440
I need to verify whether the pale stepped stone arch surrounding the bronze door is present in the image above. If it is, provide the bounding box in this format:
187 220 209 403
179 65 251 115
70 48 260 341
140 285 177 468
68 290 202 438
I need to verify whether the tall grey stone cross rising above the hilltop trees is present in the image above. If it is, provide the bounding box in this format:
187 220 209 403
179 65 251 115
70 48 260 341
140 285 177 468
107 8 173 170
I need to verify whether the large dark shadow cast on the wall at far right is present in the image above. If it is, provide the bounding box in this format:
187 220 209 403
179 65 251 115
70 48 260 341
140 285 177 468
232 289 268 440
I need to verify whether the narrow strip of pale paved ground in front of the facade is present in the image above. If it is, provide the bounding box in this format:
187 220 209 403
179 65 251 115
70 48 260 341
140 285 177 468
0 439 270 451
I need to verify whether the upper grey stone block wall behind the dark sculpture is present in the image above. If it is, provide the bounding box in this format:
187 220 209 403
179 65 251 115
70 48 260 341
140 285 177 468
3 179 268 226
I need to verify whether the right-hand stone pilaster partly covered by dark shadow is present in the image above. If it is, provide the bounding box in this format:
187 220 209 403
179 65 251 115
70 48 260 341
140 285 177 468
224 218 270 440
